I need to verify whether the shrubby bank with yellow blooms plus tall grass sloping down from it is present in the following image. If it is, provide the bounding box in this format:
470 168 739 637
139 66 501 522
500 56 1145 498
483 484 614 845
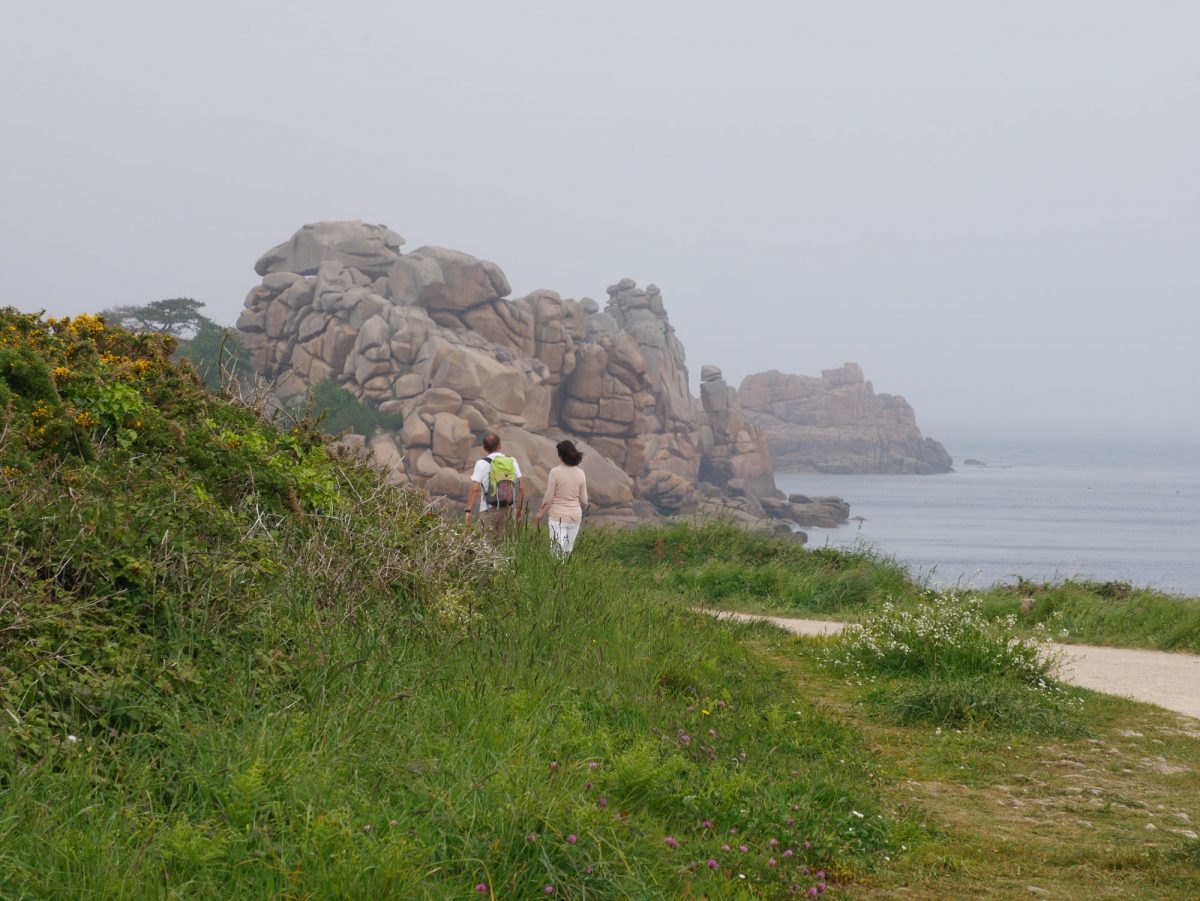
0 312 920 897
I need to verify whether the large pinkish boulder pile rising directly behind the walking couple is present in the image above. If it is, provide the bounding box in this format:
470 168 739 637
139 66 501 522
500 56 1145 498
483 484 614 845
238 222 792 521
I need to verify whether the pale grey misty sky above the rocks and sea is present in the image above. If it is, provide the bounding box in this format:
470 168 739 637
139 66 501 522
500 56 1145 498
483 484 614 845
0 0 1200 443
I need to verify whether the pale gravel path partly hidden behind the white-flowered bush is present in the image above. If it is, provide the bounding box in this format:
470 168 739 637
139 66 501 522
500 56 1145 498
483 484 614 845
707 611 1200 720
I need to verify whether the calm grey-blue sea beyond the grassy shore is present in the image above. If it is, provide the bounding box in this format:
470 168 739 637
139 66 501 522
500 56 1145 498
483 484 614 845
775 440 1200 596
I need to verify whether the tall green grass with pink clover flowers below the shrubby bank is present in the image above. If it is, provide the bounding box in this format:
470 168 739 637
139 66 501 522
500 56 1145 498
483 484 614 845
0 525 910 897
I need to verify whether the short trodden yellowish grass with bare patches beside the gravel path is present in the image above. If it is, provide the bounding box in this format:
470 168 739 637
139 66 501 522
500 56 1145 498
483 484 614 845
730 626 1200 899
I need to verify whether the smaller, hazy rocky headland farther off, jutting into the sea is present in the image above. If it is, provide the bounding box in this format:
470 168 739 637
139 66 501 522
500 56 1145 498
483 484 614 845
738 362 953 474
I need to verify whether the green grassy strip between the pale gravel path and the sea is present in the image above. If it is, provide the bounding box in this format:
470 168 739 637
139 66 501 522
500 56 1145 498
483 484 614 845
607 523 1200 653
